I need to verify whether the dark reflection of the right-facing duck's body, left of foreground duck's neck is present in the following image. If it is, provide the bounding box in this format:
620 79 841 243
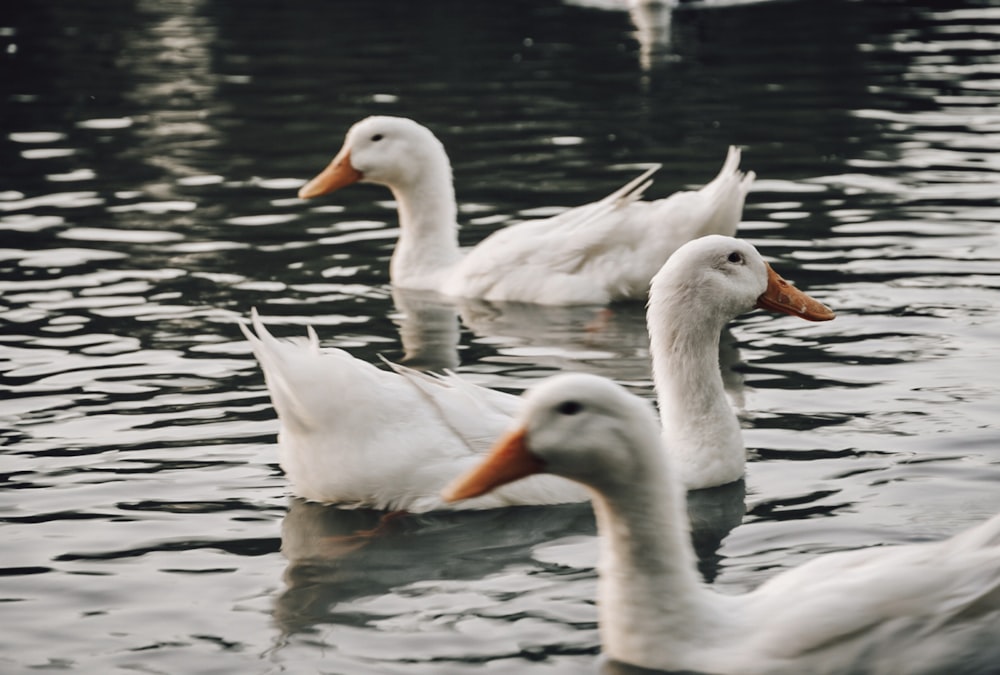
274 499 596 635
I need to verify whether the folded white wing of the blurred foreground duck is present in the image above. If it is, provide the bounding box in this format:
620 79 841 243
746 516 1000 673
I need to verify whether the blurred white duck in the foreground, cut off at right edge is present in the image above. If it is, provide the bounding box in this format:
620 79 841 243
445 374 1000 675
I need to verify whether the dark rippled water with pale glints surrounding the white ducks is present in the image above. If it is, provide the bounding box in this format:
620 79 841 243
0 0 1000 673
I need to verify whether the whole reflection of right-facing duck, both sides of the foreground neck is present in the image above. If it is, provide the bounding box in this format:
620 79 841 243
274 481 745 643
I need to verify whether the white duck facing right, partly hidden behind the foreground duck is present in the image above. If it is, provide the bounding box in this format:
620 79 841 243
241 235 833 512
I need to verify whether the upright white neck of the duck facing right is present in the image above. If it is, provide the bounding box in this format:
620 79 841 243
647 290 746 490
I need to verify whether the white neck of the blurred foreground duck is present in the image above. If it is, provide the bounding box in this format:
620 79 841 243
593 464 725 670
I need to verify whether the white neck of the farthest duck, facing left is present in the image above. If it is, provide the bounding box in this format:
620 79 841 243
389 157 460 290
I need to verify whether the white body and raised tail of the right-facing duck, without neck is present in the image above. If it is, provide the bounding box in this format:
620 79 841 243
241 312 586 513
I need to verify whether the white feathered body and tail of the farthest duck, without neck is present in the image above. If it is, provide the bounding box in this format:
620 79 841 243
447 147 753 305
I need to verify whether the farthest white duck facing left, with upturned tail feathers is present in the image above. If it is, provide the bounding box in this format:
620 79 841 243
299 116 754 305
